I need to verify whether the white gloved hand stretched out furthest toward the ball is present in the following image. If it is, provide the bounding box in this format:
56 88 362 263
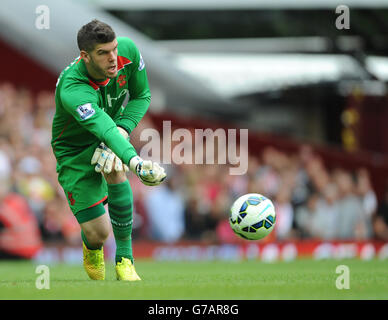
129 156 166 186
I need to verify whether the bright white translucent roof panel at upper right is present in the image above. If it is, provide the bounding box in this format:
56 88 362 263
175 53 370 98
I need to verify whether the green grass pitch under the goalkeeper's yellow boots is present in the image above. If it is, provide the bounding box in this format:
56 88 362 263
0 259 388 300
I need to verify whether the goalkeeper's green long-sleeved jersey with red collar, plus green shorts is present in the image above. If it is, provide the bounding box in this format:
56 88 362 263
51 37 151 212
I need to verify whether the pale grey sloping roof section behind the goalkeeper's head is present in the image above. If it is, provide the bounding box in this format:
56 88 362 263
0 0 234 115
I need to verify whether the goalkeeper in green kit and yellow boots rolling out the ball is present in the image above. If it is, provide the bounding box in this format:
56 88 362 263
51 20 166 281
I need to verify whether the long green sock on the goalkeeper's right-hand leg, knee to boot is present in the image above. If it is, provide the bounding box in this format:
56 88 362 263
108 180 133 263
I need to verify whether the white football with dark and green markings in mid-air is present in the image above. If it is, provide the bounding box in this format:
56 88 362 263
229 193 276 240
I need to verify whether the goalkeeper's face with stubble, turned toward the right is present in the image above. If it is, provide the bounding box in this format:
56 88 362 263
84 39 118 80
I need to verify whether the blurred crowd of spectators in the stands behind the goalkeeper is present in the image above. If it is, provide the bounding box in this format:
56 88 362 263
0 83 388 258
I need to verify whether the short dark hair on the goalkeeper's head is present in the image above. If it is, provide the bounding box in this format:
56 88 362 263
77 19 116 52
